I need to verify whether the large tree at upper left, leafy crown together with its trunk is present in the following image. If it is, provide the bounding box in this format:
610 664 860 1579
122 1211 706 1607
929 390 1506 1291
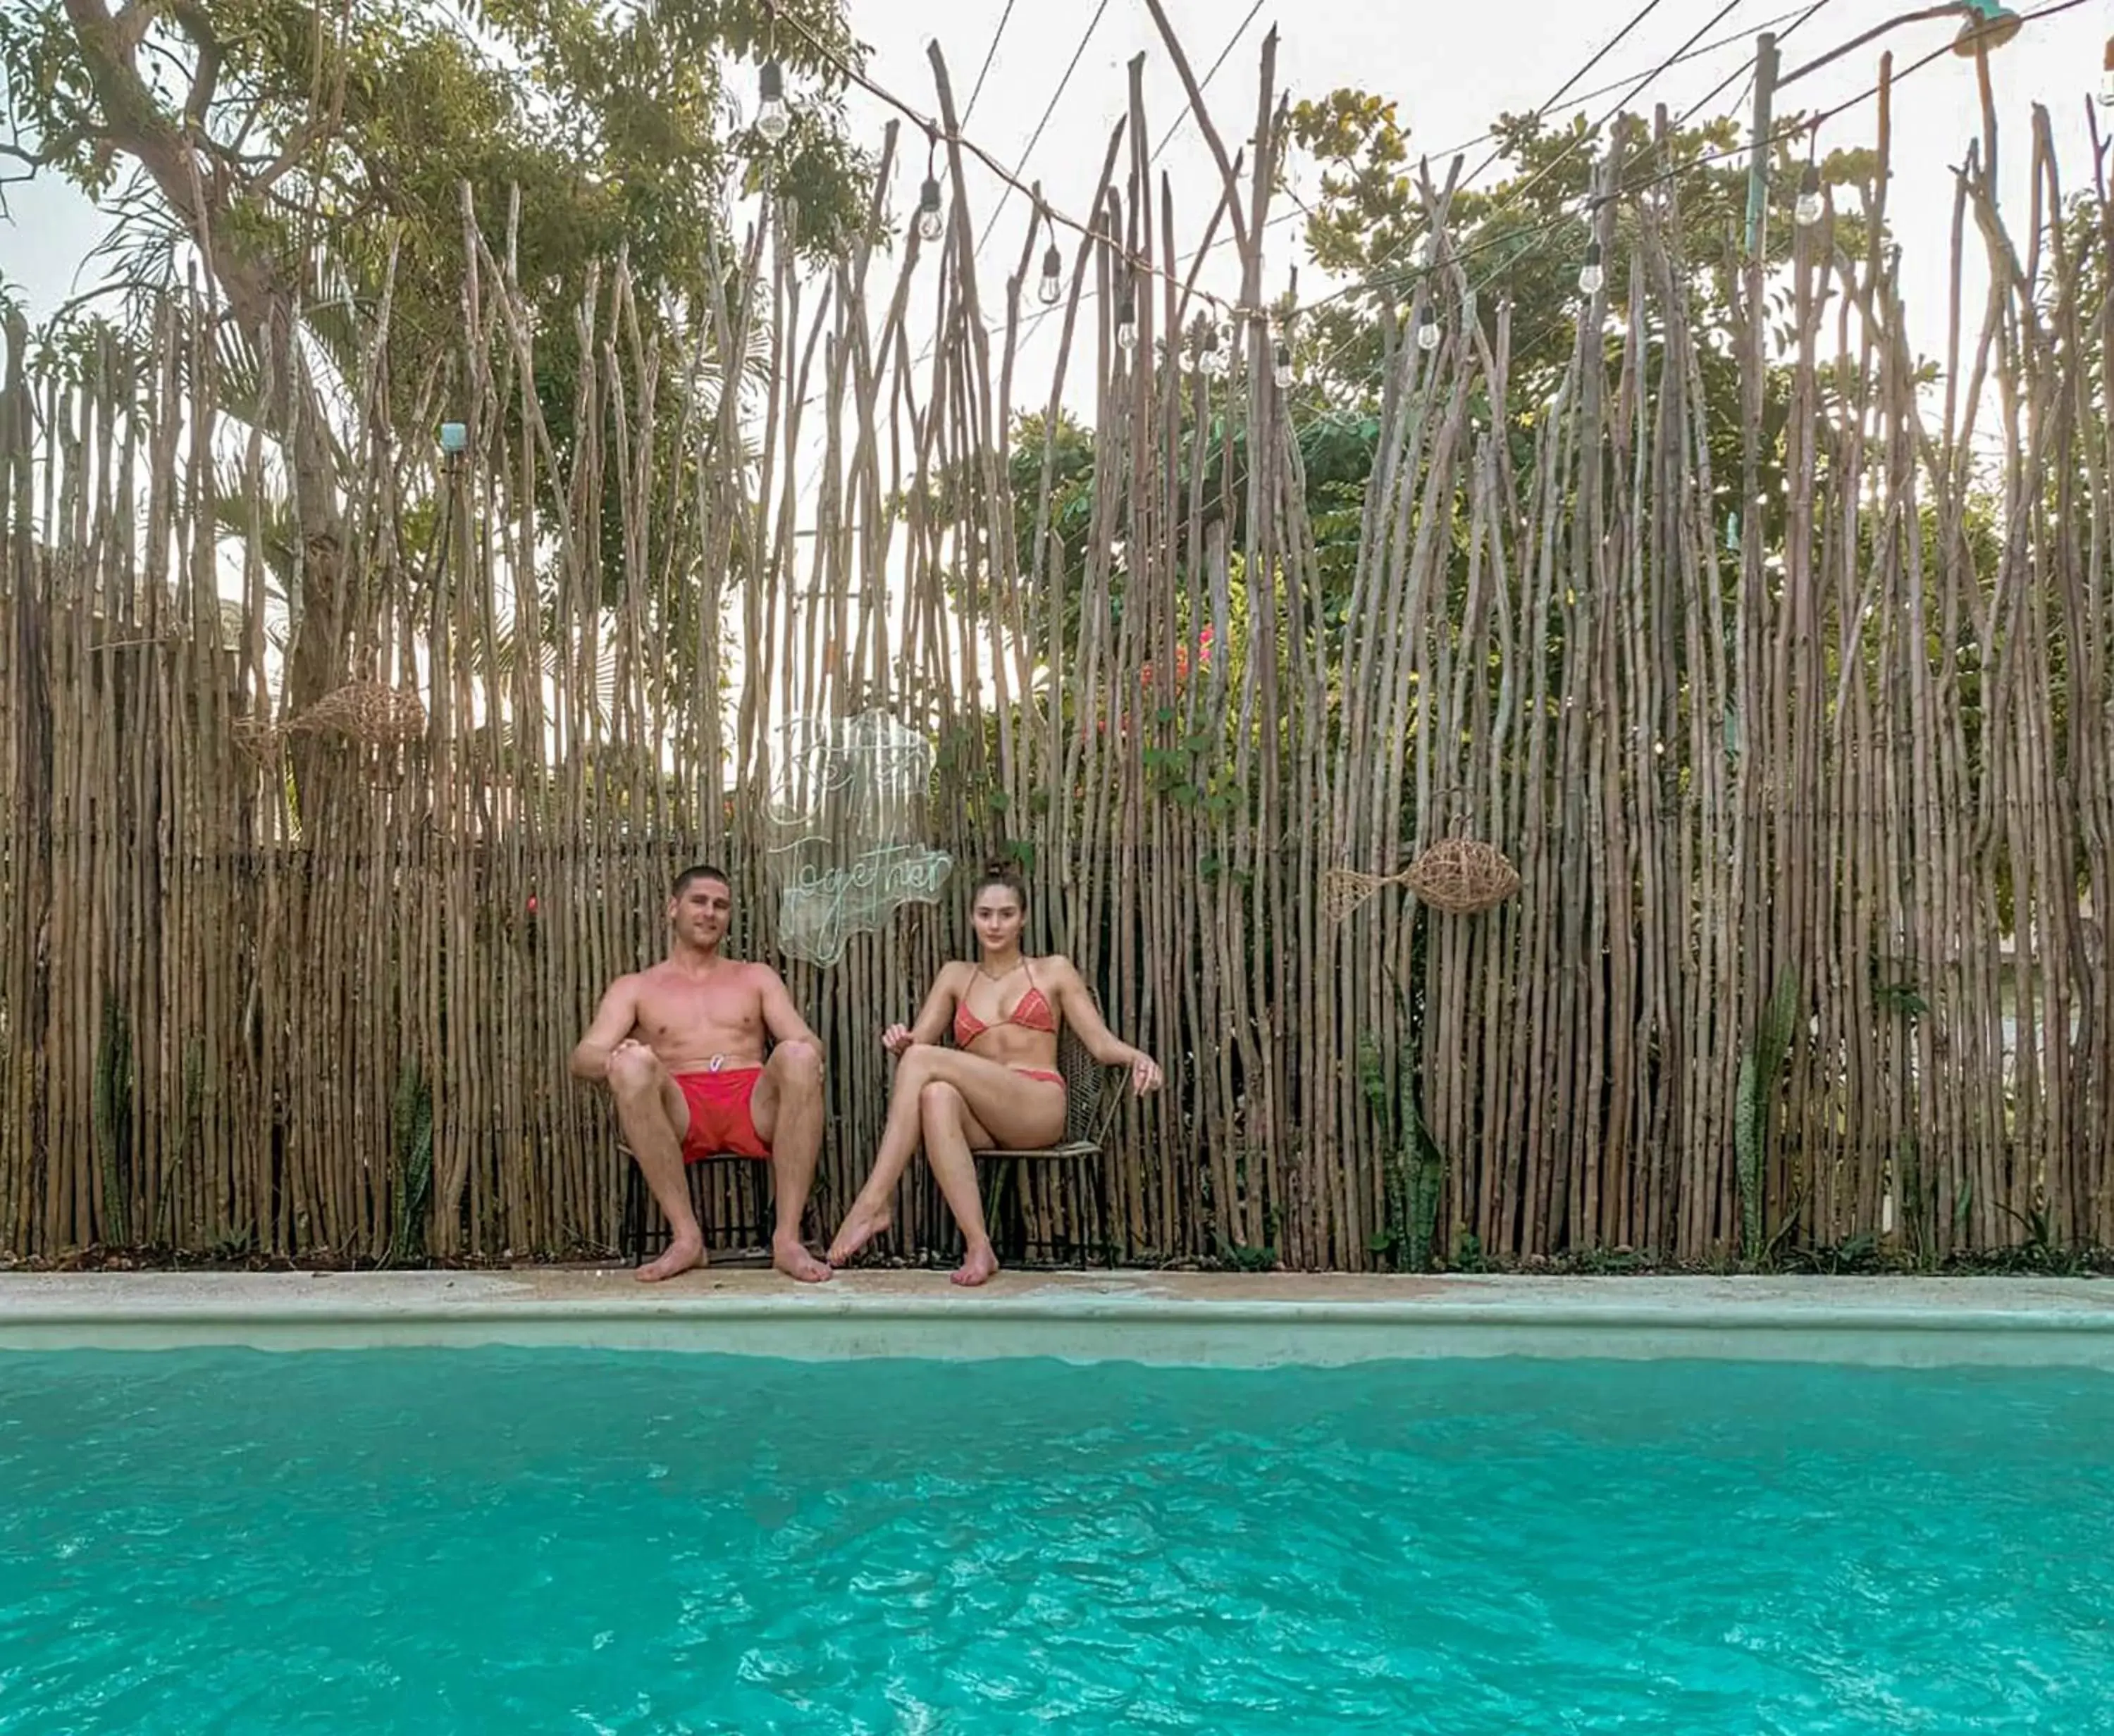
0 0 867 702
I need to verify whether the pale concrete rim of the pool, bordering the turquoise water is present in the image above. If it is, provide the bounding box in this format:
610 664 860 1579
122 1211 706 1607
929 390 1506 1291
0 1286 2114 1370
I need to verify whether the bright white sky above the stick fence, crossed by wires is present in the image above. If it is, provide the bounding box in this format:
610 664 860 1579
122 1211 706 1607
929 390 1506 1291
0 0 2114 444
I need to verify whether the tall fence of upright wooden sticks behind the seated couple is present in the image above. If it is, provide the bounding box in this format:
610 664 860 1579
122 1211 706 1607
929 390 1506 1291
0 42 2114 1269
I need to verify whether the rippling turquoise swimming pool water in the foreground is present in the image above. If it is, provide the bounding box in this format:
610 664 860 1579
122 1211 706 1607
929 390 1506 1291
0 1351 2114 1736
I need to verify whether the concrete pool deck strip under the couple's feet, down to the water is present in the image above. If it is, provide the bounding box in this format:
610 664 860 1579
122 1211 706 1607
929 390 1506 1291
0 1267 2114 1370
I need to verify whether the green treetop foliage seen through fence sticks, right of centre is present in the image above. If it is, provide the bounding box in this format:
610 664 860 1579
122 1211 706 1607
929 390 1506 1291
951 89 1911 693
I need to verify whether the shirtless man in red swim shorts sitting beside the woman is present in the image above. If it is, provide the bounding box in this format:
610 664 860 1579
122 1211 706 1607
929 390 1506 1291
573 867 829 1284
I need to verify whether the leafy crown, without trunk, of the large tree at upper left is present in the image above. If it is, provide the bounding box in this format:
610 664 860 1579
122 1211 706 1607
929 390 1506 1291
0 0 867 315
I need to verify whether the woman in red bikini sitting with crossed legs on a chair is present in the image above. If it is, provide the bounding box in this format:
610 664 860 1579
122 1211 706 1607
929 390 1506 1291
829 864 1161 1284
